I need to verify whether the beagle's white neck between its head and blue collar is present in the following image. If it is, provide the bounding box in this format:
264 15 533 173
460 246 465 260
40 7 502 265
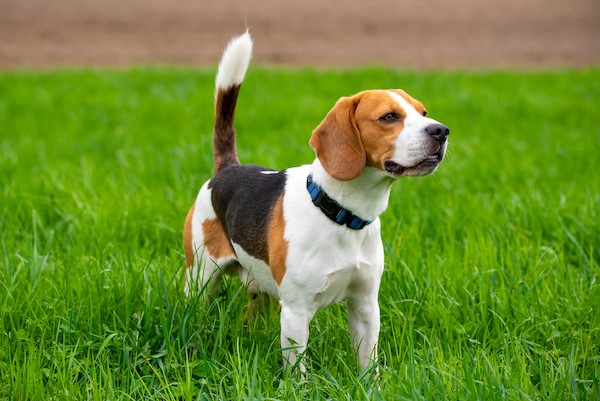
312 159 395 221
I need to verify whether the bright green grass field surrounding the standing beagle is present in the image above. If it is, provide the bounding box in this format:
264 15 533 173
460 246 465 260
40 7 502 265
0 68 600 400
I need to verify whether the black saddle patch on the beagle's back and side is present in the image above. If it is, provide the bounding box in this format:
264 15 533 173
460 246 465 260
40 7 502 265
208 164 287 263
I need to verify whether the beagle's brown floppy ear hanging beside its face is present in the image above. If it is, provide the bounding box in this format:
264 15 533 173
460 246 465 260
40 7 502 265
309 96 367 181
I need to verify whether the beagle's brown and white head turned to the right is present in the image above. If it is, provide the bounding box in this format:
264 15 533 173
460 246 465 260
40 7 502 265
310 89 450 181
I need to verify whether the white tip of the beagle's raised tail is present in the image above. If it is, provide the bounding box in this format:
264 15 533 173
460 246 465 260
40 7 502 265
216 31 252 89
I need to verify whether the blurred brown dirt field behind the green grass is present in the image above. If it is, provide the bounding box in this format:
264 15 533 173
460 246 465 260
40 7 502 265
0 0 600 69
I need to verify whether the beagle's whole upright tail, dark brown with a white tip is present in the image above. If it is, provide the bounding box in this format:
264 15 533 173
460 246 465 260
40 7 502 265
213 31 252 174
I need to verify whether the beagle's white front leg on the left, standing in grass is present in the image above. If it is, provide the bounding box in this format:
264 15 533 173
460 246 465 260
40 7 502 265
281 302 313 373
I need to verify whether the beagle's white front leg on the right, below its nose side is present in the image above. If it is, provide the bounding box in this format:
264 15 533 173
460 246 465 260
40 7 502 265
346 292 380 370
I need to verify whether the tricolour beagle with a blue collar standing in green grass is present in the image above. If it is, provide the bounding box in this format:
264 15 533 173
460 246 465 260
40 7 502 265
183 32 449 372
